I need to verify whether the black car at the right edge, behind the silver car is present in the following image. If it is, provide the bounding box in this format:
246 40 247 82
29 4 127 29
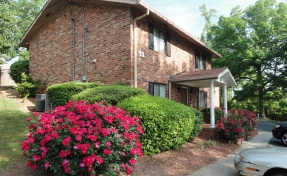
272 121 287 146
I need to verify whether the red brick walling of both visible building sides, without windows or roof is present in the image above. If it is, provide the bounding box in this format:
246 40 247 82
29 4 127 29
29 4 218 108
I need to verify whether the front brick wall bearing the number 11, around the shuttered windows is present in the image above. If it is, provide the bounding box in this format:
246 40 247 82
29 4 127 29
138 19 211 108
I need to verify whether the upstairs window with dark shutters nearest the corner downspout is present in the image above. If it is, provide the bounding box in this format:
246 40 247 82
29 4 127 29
149 23 171 57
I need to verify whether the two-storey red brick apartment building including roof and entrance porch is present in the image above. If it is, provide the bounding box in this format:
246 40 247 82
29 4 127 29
20 0 235 127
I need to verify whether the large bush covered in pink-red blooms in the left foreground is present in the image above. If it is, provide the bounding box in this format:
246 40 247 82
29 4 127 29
22 101 144 176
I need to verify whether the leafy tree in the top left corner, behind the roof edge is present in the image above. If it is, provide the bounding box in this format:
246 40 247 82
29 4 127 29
0 0 46 63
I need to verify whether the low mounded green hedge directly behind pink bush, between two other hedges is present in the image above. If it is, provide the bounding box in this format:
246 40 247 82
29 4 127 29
71 85 146 105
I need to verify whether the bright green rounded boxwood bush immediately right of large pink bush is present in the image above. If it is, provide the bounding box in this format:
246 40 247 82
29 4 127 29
117 95 195 155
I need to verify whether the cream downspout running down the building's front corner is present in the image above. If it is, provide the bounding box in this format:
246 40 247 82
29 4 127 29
134 9 149 88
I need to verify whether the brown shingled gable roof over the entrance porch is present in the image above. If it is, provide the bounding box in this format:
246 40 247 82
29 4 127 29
169 68 236 88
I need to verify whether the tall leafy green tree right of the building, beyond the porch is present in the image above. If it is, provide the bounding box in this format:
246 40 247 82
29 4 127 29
209 0 287 117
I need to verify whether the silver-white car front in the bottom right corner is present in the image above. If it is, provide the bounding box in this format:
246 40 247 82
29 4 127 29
234 147 287 176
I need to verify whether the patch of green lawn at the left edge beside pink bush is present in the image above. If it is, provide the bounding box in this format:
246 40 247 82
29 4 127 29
0 97 31 169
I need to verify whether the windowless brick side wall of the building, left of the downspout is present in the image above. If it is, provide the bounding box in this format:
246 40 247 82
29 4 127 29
29 5 132 85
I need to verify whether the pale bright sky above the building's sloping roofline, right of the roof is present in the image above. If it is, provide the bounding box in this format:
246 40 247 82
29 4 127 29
143 0 287 38
